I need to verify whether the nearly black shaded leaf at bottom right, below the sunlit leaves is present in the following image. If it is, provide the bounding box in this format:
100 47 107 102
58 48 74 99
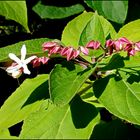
91 120 136 140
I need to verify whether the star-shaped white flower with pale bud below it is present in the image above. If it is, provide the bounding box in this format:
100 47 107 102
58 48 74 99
6 44 36 78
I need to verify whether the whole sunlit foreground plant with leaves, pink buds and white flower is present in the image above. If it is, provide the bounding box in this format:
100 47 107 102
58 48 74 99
0 12 140 139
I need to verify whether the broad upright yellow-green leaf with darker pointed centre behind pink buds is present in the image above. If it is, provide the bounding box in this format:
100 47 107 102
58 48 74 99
61 12 116 48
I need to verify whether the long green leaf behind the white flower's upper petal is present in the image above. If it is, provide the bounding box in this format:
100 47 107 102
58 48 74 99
0 38 50 62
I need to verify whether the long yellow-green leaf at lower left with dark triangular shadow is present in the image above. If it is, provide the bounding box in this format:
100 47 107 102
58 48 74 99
0 74 49 129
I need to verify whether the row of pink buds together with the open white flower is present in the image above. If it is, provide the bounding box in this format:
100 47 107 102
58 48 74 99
6 37 140 78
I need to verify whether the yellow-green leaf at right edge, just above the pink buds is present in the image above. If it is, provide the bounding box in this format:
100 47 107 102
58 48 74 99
117 19 140 42
